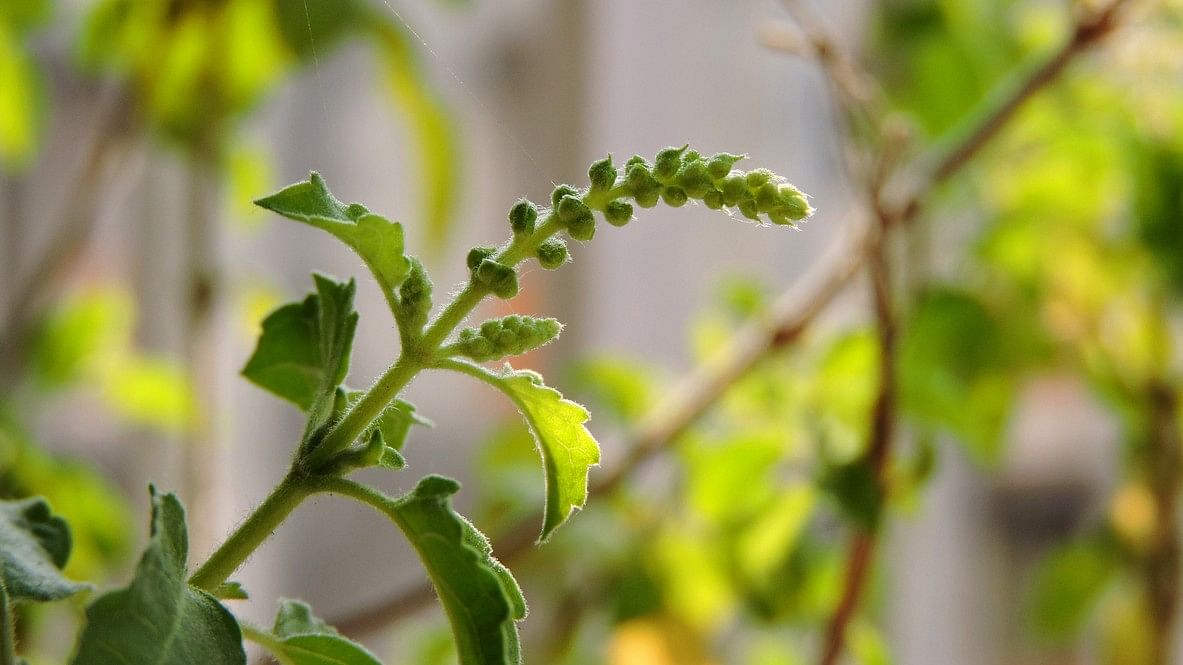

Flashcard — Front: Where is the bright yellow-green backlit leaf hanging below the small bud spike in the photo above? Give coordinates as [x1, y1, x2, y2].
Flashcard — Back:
[440, 361, 600, 542]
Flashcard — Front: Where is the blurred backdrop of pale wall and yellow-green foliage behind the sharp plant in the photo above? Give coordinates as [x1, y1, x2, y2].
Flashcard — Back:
[0, 0, 1183, 665]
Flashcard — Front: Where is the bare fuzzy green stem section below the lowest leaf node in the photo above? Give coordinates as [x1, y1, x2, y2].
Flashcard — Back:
[189, 474, 312, 592]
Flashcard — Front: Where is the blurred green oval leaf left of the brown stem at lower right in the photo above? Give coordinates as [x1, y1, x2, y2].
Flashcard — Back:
[1028, 540, 1118, 641]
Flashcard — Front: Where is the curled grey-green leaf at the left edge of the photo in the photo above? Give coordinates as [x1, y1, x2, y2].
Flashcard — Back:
[0, 498, 88, 601]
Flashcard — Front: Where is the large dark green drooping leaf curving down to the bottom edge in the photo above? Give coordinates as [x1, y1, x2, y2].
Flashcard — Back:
[323, 476, 526, 665]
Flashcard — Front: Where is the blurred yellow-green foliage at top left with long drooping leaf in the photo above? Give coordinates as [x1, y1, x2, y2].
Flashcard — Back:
[79, 0, 459, 250]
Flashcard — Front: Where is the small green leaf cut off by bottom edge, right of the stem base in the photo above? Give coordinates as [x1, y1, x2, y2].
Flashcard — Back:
[246, 599, 382, 665]
